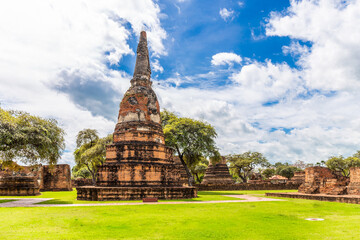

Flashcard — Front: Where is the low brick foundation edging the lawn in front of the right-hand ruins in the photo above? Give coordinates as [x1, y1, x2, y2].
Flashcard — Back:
[265, 192, 360, 204]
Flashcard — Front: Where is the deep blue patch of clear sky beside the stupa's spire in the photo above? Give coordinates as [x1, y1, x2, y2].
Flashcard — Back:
[118, 0, 295, 81]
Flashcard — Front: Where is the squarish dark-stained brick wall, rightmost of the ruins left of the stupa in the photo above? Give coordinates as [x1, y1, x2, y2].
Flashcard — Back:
[40, 164, 72, 191]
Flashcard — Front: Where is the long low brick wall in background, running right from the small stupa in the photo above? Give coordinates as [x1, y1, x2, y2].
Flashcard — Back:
[195, 182, 300, 191]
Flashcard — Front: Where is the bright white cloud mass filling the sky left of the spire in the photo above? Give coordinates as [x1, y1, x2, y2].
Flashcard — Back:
[0, 0, 166, 166]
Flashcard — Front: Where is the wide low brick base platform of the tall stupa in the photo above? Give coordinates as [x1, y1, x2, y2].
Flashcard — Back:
[76, 186, 197, 201]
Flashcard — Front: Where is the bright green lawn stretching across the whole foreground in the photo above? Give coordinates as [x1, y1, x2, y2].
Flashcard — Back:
[0, 191, 360, 239]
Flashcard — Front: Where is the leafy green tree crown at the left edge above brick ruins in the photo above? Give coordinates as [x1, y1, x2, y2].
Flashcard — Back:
[0, 108, 65, 165]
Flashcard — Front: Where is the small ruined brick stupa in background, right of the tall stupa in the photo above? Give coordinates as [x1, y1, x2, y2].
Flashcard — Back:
[201, 157, 234, 185]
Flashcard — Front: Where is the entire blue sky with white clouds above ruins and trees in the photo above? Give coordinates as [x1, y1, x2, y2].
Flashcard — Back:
[0, 0, 360, 165]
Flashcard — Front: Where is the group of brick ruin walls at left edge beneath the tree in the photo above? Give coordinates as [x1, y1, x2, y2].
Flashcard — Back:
[0, 164, 72, 196]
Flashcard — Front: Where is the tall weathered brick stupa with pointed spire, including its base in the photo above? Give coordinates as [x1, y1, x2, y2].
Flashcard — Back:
[77, 31, 197, 201]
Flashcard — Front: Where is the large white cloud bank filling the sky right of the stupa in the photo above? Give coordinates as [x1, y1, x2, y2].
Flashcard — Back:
[157, 0, 360, 163]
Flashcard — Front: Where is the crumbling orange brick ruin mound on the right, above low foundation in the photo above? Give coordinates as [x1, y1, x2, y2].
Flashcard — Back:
[299, 167, 349, 195]
